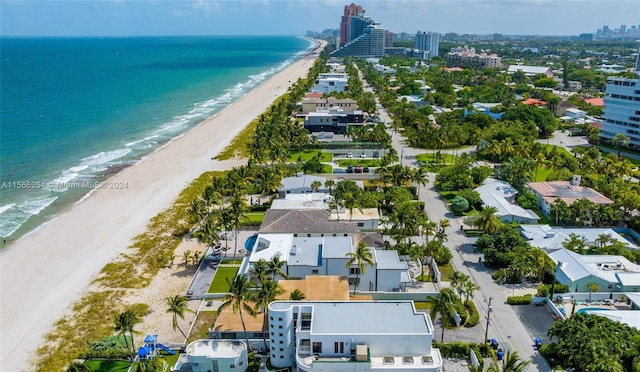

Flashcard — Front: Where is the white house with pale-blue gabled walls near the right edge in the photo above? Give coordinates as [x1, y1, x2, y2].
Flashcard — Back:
[547, 248, 640, 292]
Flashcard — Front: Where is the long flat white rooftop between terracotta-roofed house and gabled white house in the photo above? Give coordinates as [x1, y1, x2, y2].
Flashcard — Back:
[520, 225, 637, 249]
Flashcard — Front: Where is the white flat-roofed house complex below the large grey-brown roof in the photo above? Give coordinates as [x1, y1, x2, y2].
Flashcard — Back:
[239, 234, 411, 292]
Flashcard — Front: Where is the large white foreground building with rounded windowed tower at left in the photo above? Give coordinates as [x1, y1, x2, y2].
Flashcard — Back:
[269, 301, 442, 372]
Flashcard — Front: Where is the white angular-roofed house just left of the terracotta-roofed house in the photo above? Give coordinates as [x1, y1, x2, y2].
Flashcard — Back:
[475, 178, 540, 223]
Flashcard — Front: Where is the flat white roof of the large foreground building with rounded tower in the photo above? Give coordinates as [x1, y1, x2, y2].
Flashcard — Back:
[269, 301, 433, 336]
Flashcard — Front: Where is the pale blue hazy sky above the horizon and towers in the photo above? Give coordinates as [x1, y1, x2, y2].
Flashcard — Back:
[0, 0, 640, 36]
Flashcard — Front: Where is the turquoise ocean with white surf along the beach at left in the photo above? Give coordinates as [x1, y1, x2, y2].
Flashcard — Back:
[0, 36, 313, 246]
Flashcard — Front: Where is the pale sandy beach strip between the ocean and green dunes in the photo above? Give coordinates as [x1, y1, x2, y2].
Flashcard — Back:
[0, 41, 315, 371]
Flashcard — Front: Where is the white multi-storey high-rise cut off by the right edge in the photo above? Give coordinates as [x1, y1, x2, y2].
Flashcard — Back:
[600, 76, 640, 148]
